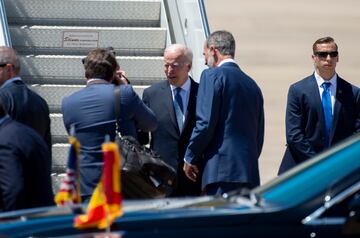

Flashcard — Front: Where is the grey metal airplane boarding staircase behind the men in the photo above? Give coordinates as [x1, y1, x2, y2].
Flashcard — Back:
[0, 0, 208, 191]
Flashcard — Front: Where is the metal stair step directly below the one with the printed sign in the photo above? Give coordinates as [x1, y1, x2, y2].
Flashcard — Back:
[20, 55, 164, 85]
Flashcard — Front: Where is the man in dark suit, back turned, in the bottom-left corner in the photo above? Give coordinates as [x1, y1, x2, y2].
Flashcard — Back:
[0, 100, 54, 211]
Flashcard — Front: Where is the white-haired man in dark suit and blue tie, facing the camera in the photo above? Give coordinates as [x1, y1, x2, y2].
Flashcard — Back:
[143, 44, 200, 196]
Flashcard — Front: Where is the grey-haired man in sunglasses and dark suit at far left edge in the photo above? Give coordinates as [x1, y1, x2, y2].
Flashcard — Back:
[0, 46, 51, 152]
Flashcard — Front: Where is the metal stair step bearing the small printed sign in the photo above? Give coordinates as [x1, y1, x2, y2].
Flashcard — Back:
[9, 25, 166, 56]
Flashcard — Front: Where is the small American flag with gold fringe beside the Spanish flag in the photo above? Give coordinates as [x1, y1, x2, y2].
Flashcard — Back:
[55, 136, 81, 205]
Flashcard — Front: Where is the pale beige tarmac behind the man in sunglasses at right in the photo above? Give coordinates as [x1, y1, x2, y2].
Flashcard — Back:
[205, 0, 360, 183]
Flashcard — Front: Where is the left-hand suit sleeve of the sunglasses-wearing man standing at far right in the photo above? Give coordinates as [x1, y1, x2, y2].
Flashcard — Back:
[286, 85, 316, 162]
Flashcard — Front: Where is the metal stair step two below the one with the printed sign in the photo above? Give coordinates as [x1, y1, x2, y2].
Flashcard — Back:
[29, 84, 148, 113]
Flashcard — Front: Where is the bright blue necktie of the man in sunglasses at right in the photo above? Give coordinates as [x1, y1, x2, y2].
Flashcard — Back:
[321, 82, 332, 147]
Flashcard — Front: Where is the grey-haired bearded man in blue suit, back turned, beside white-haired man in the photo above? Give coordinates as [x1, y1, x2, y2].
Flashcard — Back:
[184, 31, 264, 195]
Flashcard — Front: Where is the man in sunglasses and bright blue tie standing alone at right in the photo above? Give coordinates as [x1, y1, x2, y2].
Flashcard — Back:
[279, 37, 360, 174]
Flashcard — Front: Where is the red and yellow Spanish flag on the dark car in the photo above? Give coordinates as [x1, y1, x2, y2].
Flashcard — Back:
[74, 142, 123, 229]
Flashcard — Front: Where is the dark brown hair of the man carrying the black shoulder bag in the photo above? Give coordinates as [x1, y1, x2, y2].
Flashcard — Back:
[84, 48, 118, 81]
